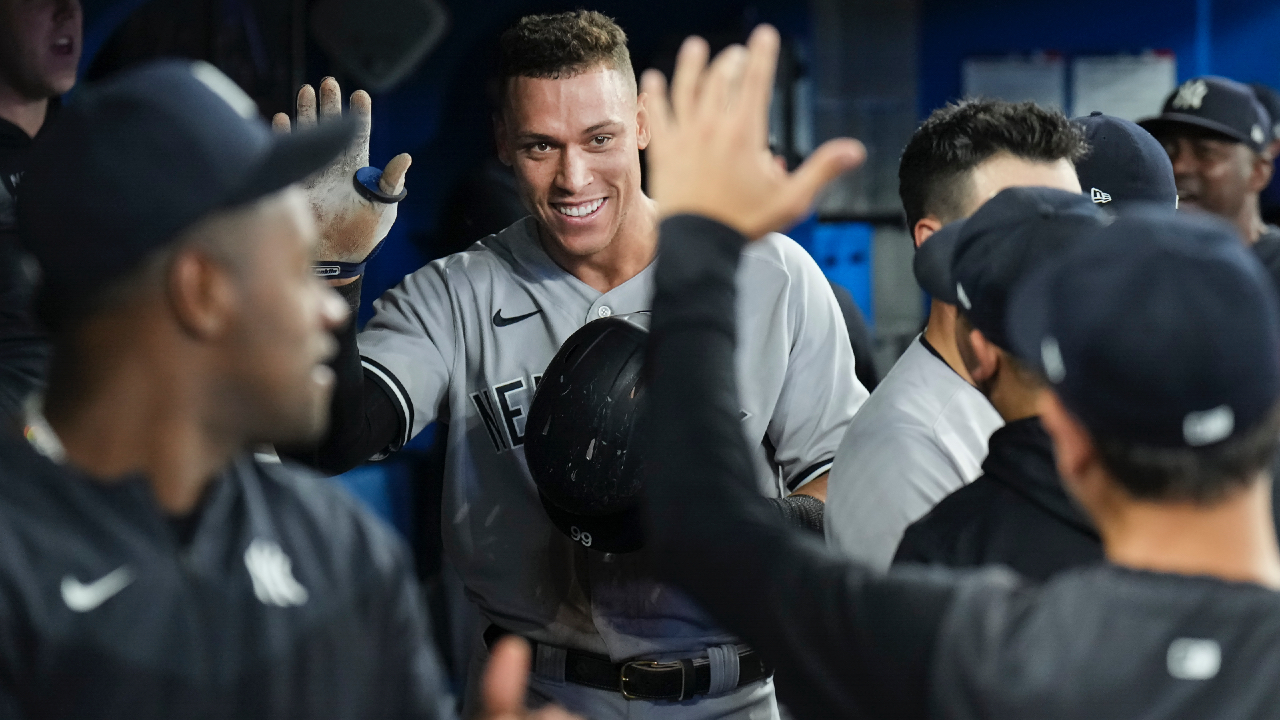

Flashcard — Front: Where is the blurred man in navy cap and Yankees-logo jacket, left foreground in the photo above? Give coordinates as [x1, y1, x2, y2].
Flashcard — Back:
[0, 61, 570, 720]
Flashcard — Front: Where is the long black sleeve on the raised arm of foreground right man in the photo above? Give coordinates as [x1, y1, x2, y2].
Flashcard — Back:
[645, 217, 950, 717]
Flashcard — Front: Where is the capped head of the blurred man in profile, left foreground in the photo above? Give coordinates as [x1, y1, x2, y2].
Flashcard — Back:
[18, 61, 353, 442]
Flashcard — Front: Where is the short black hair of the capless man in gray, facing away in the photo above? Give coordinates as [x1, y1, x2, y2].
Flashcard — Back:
[897, 100, 1088, 232]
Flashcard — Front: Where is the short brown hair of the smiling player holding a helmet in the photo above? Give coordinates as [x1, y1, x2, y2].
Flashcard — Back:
[498, 10, 635, 97]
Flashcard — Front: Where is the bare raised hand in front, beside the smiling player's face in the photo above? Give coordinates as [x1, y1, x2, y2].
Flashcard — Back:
[643, 26, 867, 240]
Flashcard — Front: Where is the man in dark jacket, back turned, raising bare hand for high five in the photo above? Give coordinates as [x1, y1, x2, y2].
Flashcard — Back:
[644, 29, 1280, 720]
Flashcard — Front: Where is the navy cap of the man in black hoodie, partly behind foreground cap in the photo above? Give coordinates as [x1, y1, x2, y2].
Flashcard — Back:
[916, 187, 1107, 350]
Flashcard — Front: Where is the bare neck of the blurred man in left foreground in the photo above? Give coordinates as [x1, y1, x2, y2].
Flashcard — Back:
[46, 327, 242, 515]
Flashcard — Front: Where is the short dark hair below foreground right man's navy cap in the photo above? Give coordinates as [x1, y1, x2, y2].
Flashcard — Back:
[1094, 406, 1280, 505]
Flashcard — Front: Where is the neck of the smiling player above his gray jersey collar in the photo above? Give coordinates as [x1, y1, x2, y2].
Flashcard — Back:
[543, 195, 658, 293]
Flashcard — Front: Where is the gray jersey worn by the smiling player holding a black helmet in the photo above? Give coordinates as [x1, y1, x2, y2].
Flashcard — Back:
[358, 218, 867, 660]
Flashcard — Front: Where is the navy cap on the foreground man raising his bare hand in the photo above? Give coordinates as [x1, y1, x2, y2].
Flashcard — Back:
[1009, 207, 1280, 447]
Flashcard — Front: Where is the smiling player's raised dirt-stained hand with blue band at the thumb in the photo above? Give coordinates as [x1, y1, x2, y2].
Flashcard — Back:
[271, 77, 413, 263]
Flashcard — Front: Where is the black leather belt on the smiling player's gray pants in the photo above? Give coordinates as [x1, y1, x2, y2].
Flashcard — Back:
[484, 625, 773, 701]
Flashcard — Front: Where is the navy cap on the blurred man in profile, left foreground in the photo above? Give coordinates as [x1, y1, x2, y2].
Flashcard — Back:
[18, 60, 356, 329]
